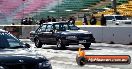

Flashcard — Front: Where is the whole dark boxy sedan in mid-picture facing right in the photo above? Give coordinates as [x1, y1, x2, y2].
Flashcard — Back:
[30, 22, 95, 49]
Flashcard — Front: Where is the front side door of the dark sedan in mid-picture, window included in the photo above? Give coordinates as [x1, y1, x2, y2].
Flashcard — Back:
[45, 24, 55, 44]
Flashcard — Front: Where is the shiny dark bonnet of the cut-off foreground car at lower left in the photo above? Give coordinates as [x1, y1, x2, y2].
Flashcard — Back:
[0, 49, 47, 64]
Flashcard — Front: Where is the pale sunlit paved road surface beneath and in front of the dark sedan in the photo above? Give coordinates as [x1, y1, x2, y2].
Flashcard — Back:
[21, 41, 132, 69]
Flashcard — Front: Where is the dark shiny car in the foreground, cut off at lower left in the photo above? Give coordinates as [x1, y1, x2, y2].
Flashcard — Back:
[0, 30, 52, 69]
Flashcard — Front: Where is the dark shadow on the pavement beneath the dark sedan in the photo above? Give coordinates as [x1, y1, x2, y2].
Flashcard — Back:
[42, 46, 101, 51]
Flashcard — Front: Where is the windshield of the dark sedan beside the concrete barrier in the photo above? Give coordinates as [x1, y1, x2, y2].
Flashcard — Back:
[53, 23, 79, 31]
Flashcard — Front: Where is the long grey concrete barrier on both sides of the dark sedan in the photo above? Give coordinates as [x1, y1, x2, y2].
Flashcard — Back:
[0, 25, 132, 44]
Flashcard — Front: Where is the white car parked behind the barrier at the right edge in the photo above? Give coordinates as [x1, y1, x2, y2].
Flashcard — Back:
[105, 15, 132, 25]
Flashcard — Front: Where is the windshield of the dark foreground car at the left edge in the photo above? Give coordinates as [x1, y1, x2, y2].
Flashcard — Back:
[0, 32, 23, 48]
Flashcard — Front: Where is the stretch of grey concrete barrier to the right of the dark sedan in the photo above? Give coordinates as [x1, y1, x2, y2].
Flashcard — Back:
[78, 26, 132, 44]
